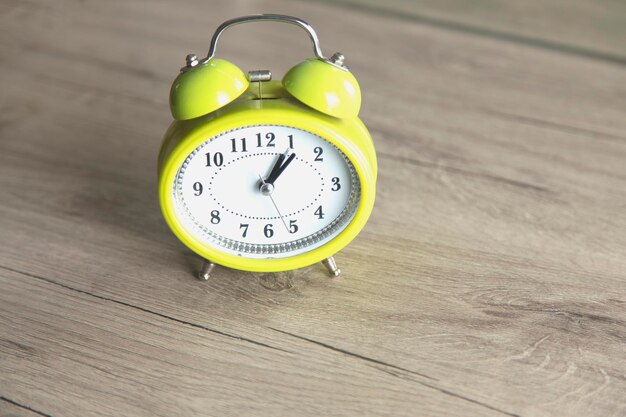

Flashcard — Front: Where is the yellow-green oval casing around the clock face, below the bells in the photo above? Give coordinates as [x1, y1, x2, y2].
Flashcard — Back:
[158, 81, 377, 272]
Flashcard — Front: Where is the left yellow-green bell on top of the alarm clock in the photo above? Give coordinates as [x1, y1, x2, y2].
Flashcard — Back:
[170, 55, 249, 120]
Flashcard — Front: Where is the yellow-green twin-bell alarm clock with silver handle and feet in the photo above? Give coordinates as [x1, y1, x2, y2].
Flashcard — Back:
[158, 15, 377, 279]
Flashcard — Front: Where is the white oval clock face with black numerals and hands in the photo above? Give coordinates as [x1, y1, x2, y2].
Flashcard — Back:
[172, 125, 361, 259]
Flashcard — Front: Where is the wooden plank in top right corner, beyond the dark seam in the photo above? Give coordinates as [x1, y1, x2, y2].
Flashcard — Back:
[322, 0, 626, 64]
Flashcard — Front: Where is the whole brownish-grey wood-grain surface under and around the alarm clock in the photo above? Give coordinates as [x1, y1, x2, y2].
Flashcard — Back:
[0, 0, 626, 417]
